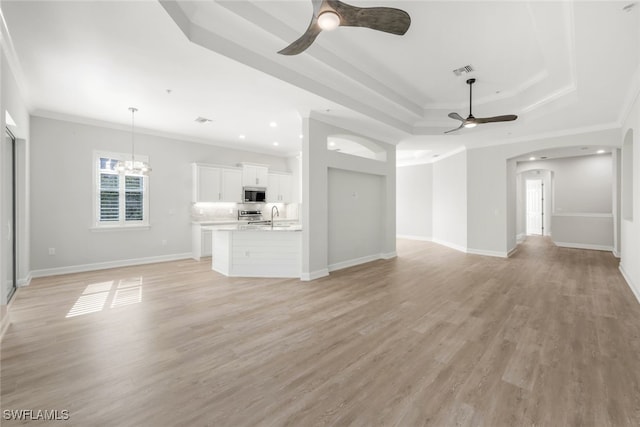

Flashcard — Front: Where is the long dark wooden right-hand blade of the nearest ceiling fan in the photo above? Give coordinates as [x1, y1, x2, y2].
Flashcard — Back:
[326, 0, 411, 36]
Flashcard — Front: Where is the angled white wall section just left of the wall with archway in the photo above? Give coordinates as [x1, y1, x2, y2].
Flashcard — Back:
[433, 151, 468, 251]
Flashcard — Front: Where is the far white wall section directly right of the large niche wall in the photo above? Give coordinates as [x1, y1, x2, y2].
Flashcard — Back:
[396, 164, 433, 240]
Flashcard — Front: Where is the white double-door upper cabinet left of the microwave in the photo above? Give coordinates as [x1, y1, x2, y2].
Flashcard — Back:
[192, 163, 242, 203]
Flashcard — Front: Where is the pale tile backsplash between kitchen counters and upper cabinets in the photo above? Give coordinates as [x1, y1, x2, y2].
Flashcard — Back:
[191, 203, 300, 222]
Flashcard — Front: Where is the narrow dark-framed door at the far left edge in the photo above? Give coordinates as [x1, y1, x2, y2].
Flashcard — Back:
[2, 129, 17, 301]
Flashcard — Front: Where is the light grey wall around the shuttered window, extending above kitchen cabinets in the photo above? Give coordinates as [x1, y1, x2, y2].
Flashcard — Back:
[31, 117, 287, 276]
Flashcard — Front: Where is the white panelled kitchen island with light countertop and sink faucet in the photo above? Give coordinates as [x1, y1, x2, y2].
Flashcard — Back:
[211, 225, 302, 278]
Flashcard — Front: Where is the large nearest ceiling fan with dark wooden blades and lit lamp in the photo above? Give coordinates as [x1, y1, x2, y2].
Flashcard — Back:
[278, 0, 411, 55]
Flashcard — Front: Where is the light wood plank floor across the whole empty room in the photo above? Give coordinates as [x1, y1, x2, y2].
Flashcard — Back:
[1, 238, 640, 427]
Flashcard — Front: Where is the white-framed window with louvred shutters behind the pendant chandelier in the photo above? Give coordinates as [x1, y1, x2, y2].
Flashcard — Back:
[94, 152, 149, 227]
